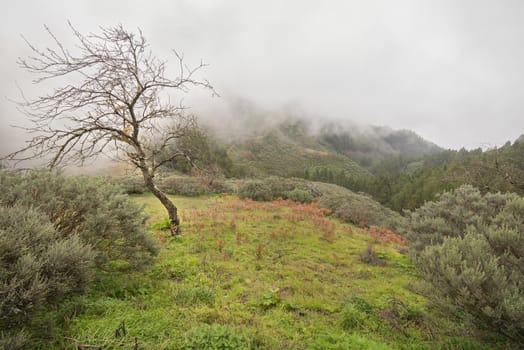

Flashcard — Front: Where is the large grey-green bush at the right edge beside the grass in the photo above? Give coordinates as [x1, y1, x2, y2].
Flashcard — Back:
[411, 186, 524, 346]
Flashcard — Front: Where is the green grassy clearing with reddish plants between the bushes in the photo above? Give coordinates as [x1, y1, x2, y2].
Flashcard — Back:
[43, 194, 508, 349]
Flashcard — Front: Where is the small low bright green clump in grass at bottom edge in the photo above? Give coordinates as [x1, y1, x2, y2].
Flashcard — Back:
[182, 324, 257, 350]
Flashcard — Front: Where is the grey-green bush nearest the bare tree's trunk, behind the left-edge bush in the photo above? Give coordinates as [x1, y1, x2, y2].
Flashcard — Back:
[0, 171, 158, 267]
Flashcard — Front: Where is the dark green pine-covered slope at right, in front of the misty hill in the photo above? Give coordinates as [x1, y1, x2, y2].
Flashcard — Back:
[367, 137, 524, 210]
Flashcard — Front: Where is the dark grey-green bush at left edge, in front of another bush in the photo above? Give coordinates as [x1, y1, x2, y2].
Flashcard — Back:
[0, 206, 95, 329]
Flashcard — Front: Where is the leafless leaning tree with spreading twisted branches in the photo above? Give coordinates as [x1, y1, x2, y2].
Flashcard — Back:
[6, 24, 215, 234]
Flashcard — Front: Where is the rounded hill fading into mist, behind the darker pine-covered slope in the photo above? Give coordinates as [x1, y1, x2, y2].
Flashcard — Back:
[219, 118, 441, 190]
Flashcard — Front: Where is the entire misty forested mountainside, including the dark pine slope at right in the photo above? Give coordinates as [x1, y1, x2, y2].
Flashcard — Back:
[181, 118, 524, 212]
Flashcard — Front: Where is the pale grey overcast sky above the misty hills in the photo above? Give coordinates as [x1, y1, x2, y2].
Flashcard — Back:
[0, 0, 524, 151]
